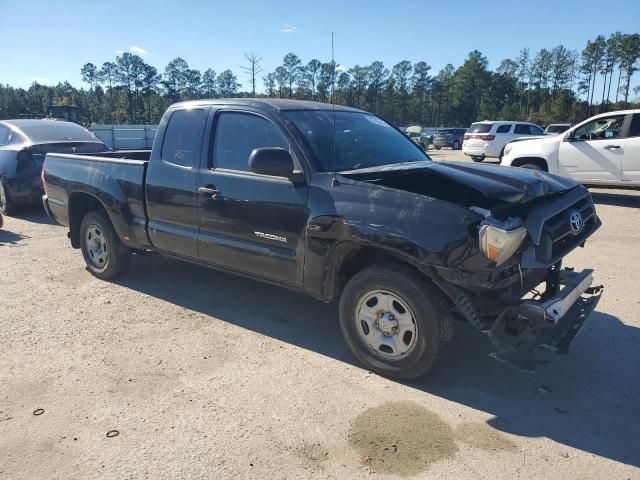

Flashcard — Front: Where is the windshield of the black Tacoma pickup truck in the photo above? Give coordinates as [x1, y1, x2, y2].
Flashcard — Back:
[283, 110, 430, 172]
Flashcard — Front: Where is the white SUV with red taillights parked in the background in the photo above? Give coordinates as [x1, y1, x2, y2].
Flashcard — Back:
[462, 121, 544, 162]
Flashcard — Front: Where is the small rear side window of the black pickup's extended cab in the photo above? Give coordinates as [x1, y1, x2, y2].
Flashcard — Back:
[162, 110, 204, 167]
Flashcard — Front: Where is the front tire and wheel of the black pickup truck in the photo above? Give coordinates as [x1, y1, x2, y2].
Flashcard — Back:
[340, 265, 453, 380]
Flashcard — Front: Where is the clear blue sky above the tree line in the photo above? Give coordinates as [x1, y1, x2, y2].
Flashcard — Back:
[0, 0, 640, 93]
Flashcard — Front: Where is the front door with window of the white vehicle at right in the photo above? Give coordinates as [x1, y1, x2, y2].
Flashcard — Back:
[558, 115, 626, 183]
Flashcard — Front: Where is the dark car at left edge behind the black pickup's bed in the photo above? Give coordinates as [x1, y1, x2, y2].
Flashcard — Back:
[0, 120, 109, 215]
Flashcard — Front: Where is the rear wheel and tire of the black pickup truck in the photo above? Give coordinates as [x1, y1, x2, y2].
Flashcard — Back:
[80, 210, 131, 280]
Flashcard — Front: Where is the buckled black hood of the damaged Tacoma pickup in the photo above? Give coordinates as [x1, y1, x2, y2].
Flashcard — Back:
[340, 161, 577, 208]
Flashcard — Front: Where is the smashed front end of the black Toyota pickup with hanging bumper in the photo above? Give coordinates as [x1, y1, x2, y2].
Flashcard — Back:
[438, 187, 603, 371]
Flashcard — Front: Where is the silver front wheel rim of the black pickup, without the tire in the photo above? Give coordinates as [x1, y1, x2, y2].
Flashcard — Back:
[355, 290, 418, 360]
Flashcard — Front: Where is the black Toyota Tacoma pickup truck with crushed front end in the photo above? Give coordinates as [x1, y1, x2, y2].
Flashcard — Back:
[42, 99, 602, 379]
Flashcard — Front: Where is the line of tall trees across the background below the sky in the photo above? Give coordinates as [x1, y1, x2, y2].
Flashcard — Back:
[0, 32, 640, 127]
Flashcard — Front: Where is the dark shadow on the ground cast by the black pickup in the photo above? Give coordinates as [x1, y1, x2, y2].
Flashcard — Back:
[117, 257, 640, 466]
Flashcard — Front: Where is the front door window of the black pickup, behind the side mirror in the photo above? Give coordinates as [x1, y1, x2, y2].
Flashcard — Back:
[213, 112, 289, 172]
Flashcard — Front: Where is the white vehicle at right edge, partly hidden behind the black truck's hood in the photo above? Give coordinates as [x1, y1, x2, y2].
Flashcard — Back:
[500, 110, 640, 186]
